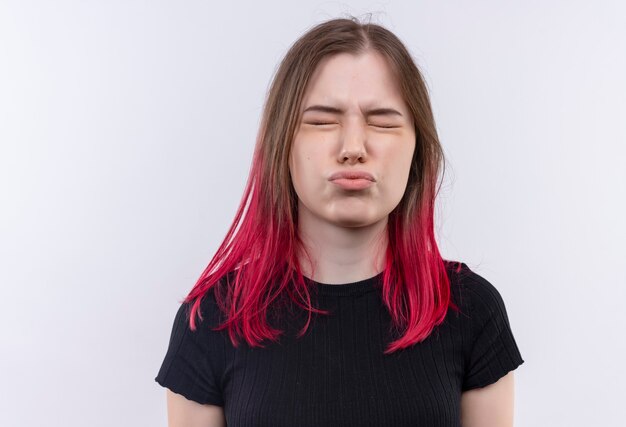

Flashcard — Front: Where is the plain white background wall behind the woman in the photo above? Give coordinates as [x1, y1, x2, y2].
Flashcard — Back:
[0, 0, 626, 427]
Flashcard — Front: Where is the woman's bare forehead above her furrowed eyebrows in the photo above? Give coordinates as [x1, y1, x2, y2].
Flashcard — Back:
[302, 51, 404, 109]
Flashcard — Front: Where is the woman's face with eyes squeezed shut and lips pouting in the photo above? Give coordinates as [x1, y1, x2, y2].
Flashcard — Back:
[289, 52, 415, 227]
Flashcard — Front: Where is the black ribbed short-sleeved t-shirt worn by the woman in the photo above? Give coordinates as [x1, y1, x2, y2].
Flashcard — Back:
[155, 264, 524, 427]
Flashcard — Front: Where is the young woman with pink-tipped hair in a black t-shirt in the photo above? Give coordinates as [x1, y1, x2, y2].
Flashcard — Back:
[155, 15, 523, 427]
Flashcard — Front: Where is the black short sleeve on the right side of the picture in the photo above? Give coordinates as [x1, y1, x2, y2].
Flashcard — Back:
[462, 272, 524, 391]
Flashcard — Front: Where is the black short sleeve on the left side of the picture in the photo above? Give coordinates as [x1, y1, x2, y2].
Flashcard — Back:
[154, 298, 224, 406]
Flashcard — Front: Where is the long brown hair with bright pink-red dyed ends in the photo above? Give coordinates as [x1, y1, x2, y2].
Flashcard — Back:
[184, 17, 460, 354]
